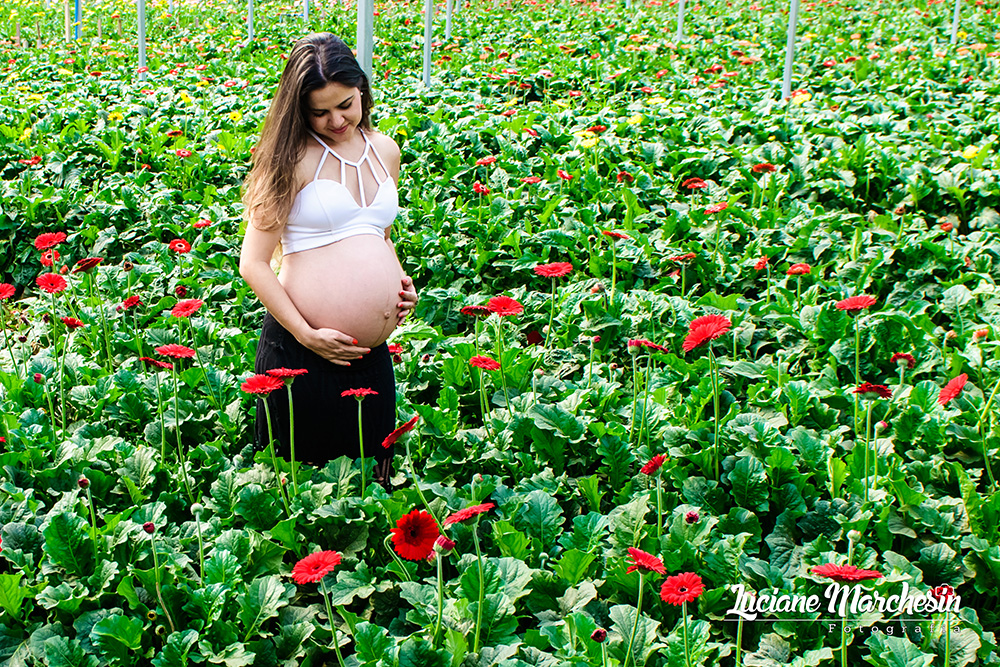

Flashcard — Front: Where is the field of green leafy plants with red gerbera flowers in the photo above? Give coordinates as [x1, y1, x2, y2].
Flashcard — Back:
[0, 0, 1000, 667]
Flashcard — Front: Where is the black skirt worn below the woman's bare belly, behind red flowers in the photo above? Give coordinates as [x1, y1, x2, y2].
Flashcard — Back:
[254, 313, 396, 484]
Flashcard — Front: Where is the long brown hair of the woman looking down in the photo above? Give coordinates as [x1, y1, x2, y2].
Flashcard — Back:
[243, 32, 372, 231]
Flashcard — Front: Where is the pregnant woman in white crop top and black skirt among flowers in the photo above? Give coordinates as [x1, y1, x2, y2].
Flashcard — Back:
[240, 33, 417, 485]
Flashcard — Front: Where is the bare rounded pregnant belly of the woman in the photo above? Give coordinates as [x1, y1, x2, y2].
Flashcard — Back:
[279, 234, 403, 347]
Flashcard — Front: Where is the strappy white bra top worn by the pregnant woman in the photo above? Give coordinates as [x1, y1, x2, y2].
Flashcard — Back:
[281, 132, 399, 255]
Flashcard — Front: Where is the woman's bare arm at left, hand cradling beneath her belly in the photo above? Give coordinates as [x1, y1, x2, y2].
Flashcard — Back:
[240, 220, 371, 366]
